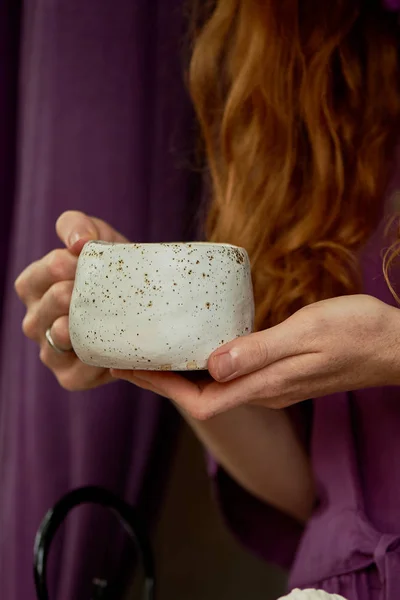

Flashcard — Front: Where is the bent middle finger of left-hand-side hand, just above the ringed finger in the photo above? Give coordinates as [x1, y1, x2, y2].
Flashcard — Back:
[22, 281, 74, 340]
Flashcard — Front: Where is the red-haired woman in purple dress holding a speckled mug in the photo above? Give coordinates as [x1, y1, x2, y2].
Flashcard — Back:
[16, 0, 400, 600]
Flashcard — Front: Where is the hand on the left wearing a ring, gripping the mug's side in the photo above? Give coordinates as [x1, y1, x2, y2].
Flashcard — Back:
[15, 211, 127, 391]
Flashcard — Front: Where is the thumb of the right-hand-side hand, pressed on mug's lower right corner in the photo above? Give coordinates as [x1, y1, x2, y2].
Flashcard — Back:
[208, 315, 305, 382]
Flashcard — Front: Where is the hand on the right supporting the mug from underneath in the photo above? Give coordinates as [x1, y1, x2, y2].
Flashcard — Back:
[112, 295, 400, 420]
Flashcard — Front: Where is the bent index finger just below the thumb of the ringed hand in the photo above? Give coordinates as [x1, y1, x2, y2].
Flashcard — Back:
[15, 248, 77, 306]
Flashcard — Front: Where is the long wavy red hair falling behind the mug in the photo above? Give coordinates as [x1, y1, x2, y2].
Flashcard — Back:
[189, 0, 400, 328]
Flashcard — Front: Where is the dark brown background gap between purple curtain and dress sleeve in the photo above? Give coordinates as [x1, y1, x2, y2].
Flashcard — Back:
[127, 427, 285, 600]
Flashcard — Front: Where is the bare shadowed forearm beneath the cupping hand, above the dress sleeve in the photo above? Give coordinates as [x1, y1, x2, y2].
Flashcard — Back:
[180, 406, 315, 522]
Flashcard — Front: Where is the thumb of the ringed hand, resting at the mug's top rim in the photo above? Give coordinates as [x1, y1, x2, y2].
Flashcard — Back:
[56, 210, 127, 254]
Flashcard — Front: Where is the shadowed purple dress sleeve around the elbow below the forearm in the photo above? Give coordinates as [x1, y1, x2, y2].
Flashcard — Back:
[208, 402, 312, 569]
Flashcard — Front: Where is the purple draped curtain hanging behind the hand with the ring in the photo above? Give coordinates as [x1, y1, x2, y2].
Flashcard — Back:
[0, 0, 198, 600]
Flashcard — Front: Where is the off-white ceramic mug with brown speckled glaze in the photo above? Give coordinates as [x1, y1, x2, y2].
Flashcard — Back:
[69, 242, 254, 371]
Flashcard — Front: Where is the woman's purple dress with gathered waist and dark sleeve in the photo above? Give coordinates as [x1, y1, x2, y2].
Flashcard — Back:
[210, 165, 400, 600]
